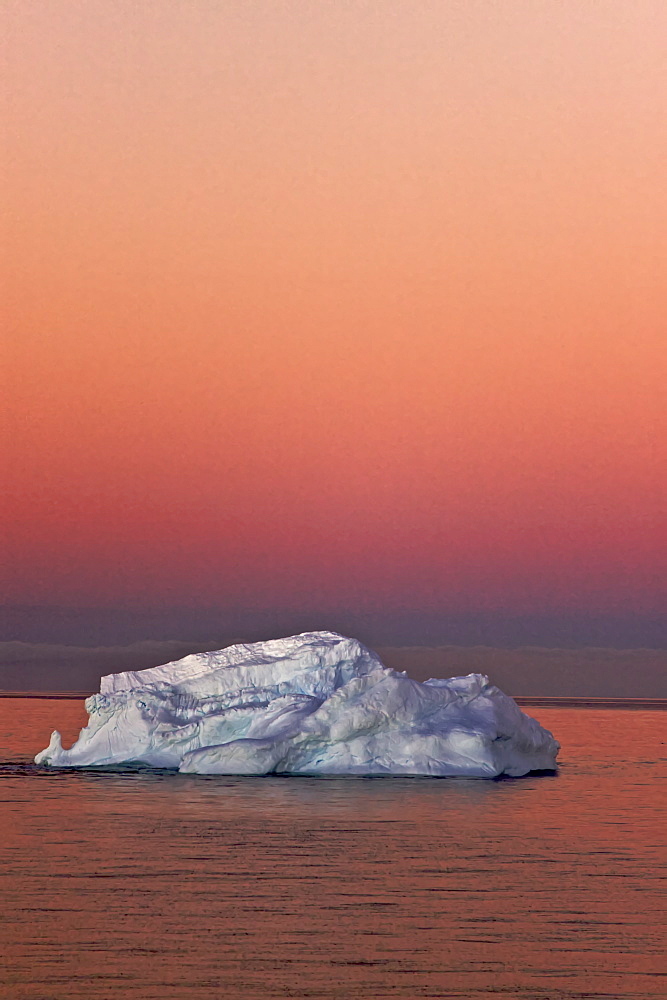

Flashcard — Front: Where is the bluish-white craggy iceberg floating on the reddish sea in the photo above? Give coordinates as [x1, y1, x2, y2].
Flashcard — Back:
[35, 632, 559, 778]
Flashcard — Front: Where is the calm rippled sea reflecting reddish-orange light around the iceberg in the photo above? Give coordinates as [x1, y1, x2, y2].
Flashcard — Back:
[0, 699, 667, 1000]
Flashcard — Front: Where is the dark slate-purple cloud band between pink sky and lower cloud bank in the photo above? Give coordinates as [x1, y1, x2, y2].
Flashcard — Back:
[0, 605, 667, 649]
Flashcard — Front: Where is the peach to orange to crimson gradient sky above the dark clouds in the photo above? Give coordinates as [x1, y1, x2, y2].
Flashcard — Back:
[2, 0, 667, 627]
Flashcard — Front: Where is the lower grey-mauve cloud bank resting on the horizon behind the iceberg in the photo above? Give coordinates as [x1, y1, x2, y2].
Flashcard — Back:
[0, 639, 667, 698]
